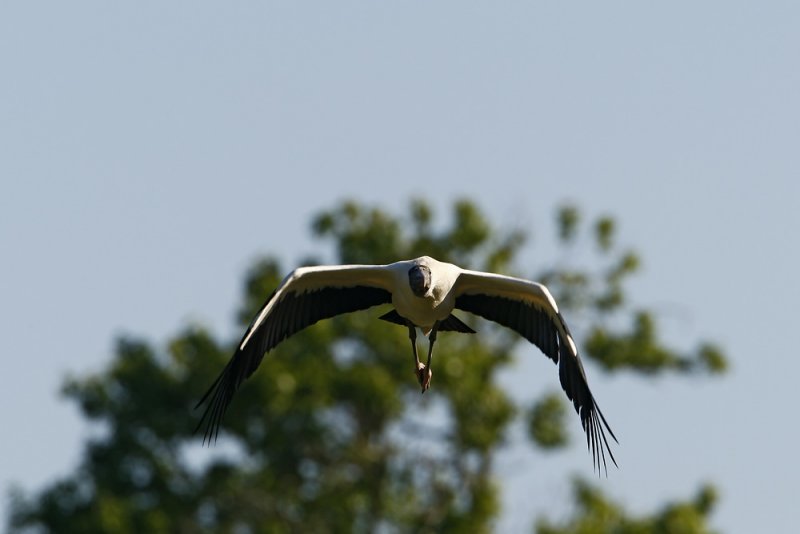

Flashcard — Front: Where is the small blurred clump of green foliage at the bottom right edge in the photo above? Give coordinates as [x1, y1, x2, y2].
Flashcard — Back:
[536, 480, 717, 534]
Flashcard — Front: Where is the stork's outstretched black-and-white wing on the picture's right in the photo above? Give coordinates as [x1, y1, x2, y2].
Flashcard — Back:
[453, 270, 617, 476]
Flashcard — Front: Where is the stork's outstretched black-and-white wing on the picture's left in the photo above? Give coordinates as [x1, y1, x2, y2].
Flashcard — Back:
[196, 265, 393, 442]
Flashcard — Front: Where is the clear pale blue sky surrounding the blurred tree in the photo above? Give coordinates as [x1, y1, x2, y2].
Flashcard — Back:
[0, 0, 800, 533]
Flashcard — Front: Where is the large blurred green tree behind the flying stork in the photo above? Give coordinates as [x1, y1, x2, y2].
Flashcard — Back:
[10, 200, 726, 533]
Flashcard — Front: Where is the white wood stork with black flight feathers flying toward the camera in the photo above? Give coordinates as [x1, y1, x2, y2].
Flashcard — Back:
[196, 256, 617, 468]
